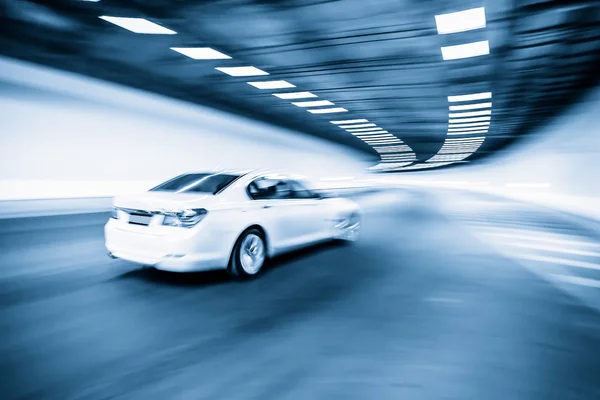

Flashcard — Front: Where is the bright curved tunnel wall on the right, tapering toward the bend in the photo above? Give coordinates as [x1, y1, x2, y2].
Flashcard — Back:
[399, 84, 600, 220]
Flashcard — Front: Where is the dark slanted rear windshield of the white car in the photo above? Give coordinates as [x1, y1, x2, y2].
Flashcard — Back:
[150, 174, 240, 194]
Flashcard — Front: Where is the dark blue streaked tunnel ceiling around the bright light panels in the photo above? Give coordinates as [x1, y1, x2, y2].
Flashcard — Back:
[0, 0, 600, 170]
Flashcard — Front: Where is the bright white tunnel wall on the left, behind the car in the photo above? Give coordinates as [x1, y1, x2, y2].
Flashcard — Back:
[0, 58, 365, 200]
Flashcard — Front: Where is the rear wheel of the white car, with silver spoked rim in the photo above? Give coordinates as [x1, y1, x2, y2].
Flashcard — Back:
[227, 228, 267, 279]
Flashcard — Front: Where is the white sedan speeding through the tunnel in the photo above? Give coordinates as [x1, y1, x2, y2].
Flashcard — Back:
[105, 171, 360, 278]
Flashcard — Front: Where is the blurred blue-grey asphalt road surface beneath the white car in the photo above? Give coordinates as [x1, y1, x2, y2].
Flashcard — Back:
[0, 191, 600, 400]
